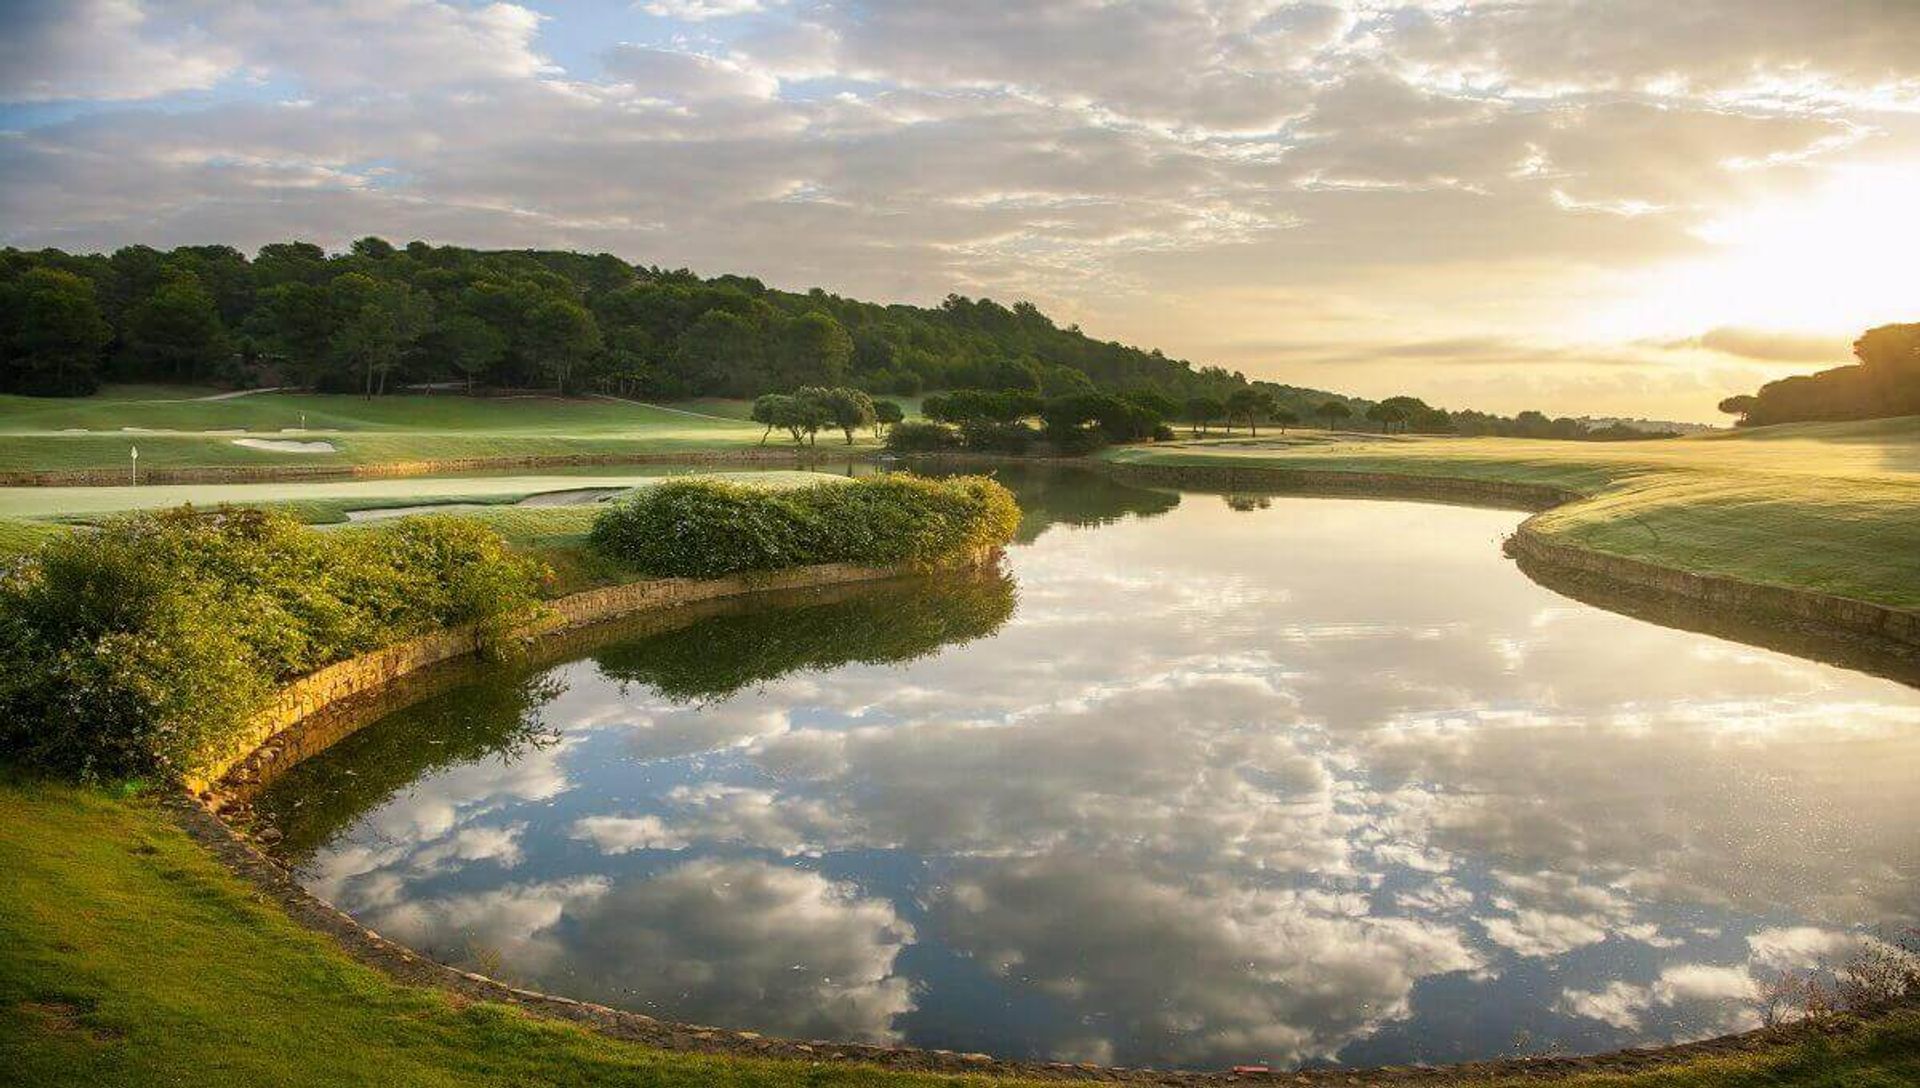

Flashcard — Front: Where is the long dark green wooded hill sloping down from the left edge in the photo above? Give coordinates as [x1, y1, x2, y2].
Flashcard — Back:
[0, 238, 1361, 405]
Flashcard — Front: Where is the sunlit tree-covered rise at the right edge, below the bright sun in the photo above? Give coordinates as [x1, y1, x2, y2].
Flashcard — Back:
[1720, 324, 1920, 426]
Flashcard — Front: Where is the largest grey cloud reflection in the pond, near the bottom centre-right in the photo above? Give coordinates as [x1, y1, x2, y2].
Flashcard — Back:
[937, 856, 1480, 1063]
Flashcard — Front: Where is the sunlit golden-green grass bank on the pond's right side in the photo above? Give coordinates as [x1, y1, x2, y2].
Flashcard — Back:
[1108, 416, 1920, 608]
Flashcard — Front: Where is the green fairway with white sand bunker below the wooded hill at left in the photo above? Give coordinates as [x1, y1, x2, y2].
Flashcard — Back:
[0, 390, 794, 472]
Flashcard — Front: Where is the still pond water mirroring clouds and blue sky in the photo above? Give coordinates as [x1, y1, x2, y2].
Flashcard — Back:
[261, 474, 1920, 1067]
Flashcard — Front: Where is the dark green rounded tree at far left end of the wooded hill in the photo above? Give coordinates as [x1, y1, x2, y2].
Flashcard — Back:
[0, 269, 113, 397]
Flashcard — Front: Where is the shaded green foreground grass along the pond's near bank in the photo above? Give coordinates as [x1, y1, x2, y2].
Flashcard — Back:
[0, 775, 1920, 1088]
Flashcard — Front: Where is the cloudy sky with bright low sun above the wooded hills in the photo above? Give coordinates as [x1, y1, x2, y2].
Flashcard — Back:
[0, 0, 1920, 420]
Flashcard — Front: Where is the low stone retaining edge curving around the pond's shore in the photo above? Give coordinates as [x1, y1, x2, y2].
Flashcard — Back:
[167, 472, 1912, 1086]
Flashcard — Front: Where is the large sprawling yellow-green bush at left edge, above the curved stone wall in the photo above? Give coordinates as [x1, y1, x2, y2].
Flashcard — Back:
[0, 507, 540, 777]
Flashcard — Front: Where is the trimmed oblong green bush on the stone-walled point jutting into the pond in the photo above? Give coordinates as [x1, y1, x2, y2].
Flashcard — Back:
[589, 474, 1020, 578]
